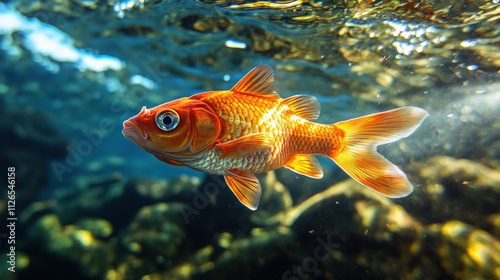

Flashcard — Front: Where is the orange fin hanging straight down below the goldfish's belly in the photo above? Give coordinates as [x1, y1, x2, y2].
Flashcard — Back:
[224, 169, 262, 210]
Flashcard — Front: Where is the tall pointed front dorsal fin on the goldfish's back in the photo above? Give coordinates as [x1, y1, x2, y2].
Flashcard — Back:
[231, 64, 279, 98]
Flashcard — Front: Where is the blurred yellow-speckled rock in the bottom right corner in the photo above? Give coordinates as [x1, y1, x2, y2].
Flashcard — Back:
[405, 221, 500, 279]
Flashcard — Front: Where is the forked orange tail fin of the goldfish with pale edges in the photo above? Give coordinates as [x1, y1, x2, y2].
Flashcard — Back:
[330, 107, 428, 197]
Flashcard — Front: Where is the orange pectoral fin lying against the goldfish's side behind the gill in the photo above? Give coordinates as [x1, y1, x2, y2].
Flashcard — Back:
[215, 133, 273, 157]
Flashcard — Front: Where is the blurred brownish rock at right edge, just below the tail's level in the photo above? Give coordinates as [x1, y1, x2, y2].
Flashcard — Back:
[402, 156, 500, 229]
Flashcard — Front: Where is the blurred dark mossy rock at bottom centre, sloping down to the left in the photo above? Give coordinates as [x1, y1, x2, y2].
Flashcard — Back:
[154, 228, 294, 280]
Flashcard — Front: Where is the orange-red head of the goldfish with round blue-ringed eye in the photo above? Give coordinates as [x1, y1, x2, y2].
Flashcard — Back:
[122, 98, 223, 163]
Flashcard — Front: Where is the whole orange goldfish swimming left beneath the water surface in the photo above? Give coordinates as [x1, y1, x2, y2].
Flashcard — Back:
[122, 65, 428, 210]
